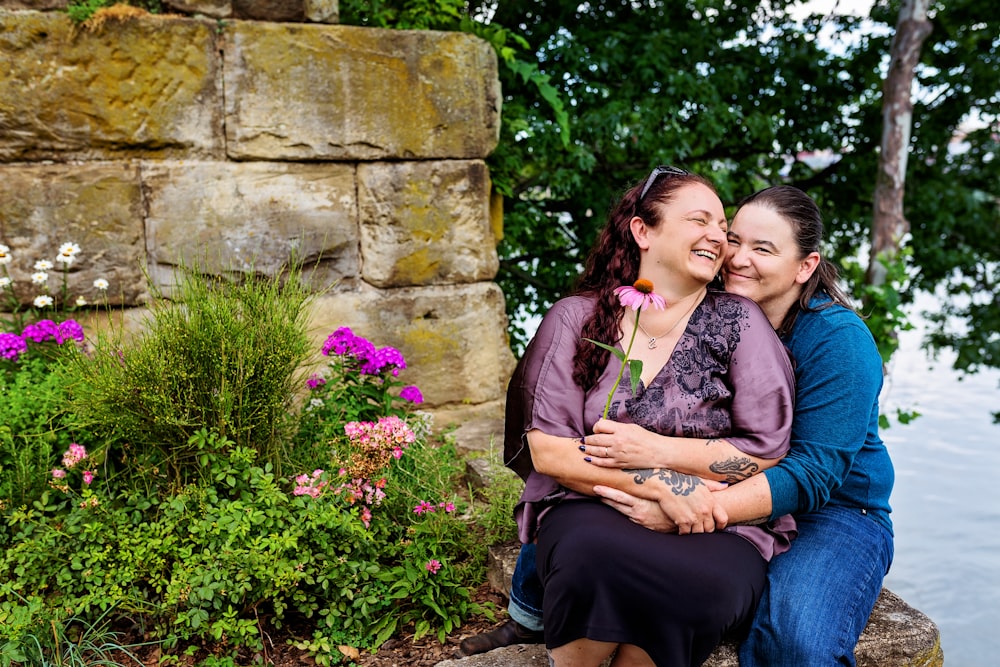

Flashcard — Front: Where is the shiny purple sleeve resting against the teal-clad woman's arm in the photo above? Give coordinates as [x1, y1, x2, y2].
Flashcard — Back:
[726, 297, 795, 459]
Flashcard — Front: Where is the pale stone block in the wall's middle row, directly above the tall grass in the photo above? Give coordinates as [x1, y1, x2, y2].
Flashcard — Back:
[142, 161, 361, 289]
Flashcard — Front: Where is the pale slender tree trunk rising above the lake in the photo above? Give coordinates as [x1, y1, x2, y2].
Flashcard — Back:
[865, 0, 931, 286]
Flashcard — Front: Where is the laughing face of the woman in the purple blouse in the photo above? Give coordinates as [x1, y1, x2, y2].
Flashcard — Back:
[632, 183, 727, 291]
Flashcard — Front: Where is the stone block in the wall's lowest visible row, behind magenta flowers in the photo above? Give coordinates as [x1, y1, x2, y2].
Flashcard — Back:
[310, 283, 514, 408]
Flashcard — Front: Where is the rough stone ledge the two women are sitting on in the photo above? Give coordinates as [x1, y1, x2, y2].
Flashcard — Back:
[436, 544, 944, 667]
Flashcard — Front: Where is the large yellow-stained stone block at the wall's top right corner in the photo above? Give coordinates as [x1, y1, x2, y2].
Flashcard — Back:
[224, 21, 500, 160]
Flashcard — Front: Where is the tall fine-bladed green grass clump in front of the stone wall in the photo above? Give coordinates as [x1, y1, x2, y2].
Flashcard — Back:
[73, 267, 309, 485]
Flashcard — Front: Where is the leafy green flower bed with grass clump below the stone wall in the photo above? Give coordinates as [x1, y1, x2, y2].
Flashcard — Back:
[0, 249, 509, 667]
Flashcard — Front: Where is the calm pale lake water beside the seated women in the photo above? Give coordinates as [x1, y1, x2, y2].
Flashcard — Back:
[882, 318, 1000, 667]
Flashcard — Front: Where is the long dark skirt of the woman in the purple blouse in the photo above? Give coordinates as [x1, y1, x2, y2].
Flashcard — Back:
[537, 500, 767, 667]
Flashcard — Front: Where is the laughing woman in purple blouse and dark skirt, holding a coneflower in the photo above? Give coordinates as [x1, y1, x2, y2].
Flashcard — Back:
[505, 167, 794, 667]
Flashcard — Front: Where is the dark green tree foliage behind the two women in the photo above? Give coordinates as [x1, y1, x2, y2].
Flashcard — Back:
[341, 0, 1000, 386]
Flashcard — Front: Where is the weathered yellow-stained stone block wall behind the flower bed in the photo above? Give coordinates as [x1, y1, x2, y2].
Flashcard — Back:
[0, 0, 514, 422]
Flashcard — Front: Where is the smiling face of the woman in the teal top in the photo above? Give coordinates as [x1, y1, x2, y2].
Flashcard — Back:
[722, 203, 819, 328]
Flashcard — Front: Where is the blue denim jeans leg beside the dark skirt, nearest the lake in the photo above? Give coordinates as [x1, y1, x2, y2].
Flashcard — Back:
[740, 506, 893, 667]
